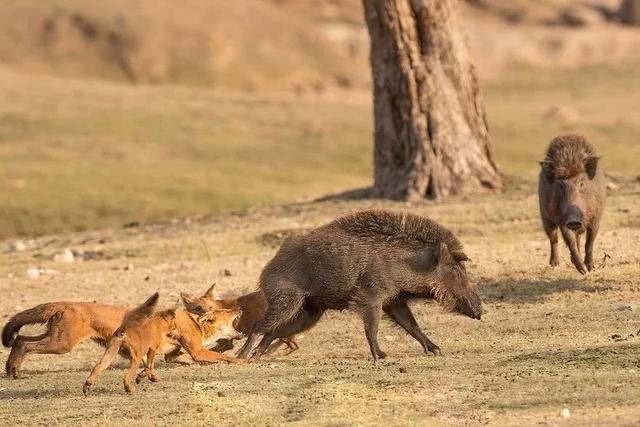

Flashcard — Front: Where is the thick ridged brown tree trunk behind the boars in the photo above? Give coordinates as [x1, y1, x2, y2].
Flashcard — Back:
[363, 0, 502, 200]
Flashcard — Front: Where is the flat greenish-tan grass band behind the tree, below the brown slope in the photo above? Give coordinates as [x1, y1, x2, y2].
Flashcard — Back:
[0, 63, 640, 238]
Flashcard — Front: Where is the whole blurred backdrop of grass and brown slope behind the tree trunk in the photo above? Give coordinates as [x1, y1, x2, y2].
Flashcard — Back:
[0, 0, 640, 238]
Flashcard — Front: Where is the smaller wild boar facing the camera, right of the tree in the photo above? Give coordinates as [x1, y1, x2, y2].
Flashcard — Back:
[538, 134, 607, 274]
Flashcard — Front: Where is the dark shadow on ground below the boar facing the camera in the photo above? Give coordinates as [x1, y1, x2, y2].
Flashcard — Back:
[478, 278, 605, 304]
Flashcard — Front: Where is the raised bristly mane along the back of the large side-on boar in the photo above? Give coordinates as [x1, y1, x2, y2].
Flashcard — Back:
[323, 210, 463, 252]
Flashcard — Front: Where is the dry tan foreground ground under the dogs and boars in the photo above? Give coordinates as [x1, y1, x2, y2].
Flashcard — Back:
[0, 180, 640, 425]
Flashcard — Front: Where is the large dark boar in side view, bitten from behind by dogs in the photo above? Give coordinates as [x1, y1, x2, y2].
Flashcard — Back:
[240, 211, 482, 361]
